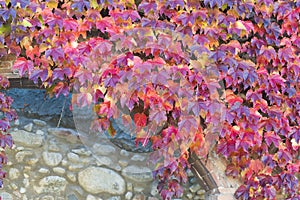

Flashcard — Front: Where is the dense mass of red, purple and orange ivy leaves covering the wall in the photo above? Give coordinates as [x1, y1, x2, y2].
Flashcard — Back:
[0, 0, 300, 199]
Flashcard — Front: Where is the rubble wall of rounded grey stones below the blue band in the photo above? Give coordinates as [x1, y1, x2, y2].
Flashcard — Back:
[0, 117, 205, 200]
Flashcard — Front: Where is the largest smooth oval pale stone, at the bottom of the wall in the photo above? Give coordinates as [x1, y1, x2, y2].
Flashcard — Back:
[78, 167, 125, 195]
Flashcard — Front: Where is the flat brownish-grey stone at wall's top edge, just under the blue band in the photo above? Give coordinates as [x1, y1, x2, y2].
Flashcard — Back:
[48, 128, 80, 143]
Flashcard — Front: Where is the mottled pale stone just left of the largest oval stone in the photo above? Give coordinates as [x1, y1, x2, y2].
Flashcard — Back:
[34, 176, 67, 194]
